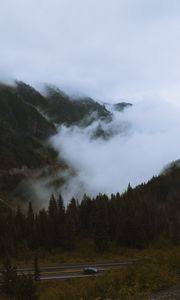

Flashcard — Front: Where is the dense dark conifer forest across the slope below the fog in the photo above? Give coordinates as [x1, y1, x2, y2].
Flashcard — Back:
[0, 165, 180, 256]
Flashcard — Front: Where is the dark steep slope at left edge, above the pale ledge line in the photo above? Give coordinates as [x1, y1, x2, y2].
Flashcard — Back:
[0, 85, 56, 170]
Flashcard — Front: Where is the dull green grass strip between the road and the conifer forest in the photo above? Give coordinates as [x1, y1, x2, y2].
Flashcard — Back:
[0, 239, 139, 267]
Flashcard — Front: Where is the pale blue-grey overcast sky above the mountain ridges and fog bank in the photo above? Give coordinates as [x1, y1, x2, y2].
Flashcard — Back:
[0, 0, 180, 103]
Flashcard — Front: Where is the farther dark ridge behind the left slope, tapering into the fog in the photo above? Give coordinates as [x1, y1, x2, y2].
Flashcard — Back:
[16, 82, 111, 126]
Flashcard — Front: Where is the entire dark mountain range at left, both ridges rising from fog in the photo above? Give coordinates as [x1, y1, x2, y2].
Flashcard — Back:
[0, 82, 132, 204]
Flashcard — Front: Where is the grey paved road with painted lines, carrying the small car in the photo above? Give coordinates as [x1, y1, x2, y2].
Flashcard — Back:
[0, 260, 136, 281]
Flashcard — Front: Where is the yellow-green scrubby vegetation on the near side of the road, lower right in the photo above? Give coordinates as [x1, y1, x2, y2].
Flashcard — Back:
[39, 248, 180, 300]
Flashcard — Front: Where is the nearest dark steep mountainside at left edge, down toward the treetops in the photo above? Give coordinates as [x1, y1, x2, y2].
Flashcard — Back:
[0, 84, 59, 200]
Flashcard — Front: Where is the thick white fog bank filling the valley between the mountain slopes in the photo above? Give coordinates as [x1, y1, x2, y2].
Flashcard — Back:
[51, 99, 180, 201]
